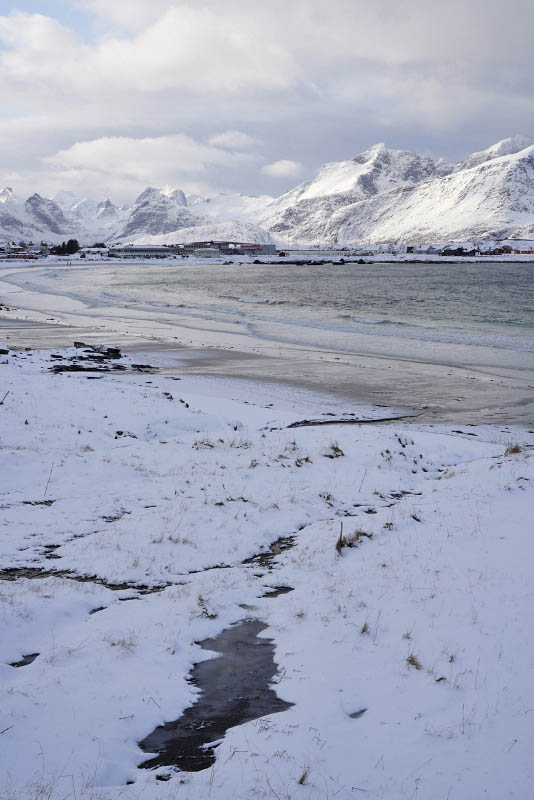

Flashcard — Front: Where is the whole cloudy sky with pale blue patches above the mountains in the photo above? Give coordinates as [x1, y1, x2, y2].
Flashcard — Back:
[0, 0, 534, 202]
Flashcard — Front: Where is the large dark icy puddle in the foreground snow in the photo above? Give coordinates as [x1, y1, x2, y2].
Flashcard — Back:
[139, 620, 293, 772]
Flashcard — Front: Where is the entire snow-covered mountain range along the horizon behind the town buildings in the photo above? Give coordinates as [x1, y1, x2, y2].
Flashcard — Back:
[0, 136, 534, 246]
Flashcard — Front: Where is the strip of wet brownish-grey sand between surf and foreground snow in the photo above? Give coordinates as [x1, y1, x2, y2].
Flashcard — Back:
[0, 310, 534, 428]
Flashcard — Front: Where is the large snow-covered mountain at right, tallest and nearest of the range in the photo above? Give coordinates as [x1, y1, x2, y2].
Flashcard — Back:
[258, 137, 534, 245]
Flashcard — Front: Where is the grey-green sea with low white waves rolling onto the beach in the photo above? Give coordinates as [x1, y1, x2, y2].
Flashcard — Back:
[4, 261, 534, 368]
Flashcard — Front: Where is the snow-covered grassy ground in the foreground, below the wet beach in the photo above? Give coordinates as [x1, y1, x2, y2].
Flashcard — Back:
[0, 350, 534, 800]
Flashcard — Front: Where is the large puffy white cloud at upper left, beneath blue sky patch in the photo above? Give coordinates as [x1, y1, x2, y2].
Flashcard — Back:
[0, 6, 299, 102]
